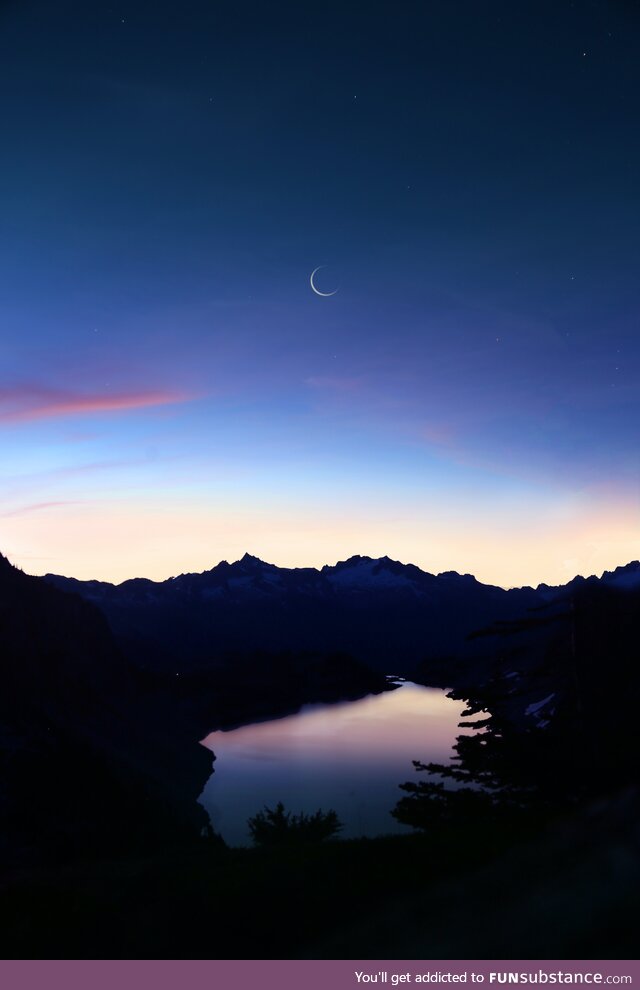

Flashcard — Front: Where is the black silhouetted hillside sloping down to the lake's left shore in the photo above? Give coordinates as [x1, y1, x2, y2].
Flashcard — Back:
[0, 557, 210, 865]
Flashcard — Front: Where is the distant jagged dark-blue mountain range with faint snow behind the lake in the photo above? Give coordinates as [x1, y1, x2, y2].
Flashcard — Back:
[45, 554, 640, 676]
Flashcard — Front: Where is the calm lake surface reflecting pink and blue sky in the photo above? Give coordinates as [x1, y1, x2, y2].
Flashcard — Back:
[200, 683, 464, 845]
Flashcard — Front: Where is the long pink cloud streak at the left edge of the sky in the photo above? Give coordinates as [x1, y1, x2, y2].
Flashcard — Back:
[0, 385, 193, 423]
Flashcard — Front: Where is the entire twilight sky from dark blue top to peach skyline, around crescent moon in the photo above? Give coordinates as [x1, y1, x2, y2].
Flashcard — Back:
[0, 0, 640, 586]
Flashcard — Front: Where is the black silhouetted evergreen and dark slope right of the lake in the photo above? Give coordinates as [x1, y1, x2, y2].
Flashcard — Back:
[392, 582, 640, 829]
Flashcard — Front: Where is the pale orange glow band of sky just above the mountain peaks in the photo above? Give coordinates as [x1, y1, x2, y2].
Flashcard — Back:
[0, 500, 640, 587]
